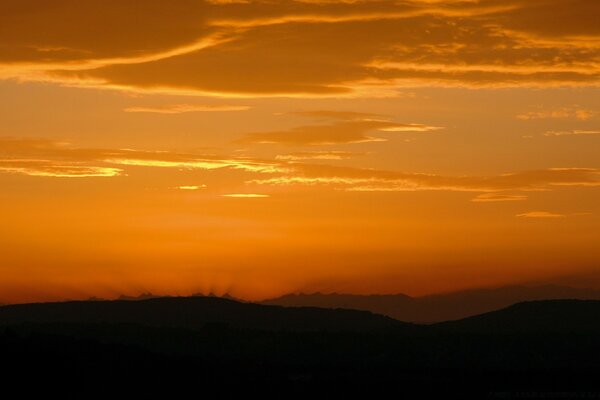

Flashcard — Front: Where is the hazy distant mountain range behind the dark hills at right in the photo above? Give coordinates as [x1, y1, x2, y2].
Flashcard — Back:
[260, 285, 600, 323]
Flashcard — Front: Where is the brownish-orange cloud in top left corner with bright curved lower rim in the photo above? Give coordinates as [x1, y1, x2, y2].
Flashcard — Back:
[0, 0, 216, 66]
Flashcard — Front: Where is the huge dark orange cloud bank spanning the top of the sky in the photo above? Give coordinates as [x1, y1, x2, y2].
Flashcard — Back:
[0, 0, 600, 95]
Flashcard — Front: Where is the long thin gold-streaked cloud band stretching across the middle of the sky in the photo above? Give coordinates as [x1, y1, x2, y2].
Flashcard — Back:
[0, 138, 600, 201]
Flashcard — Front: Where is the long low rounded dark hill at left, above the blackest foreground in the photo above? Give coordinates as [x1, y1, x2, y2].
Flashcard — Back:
[0, 296, 410, 331]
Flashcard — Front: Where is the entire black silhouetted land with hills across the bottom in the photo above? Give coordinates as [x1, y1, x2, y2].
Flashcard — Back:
[0, 297, 600, 399]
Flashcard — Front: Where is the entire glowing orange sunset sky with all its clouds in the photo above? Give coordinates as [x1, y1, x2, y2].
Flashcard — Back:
[0, 0, 600, 303]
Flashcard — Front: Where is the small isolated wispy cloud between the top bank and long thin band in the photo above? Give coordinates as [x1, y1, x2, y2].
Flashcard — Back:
[237, 111, 442, 146]
